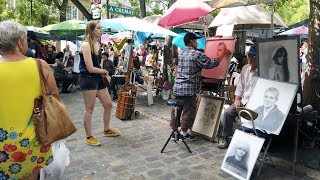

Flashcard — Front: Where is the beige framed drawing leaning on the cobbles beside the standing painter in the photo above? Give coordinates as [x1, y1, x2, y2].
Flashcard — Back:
[192, 95, 224, 141]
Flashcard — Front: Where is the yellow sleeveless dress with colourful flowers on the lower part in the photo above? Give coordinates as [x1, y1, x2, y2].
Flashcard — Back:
[0, 58, 53, 179]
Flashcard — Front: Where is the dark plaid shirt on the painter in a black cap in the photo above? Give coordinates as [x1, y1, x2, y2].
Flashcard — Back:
[173, 47, 220, 96]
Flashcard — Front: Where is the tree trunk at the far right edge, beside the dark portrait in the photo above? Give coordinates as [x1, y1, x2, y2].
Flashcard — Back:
[303, 0, 320, 111]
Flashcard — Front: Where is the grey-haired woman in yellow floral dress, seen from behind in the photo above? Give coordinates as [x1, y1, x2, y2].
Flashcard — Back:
[0, 21, 58, 179]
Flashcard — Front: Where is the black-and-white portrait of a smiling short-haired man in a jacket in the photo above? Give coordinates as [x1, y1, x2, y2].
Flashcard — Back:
[241, 78, 297, 135]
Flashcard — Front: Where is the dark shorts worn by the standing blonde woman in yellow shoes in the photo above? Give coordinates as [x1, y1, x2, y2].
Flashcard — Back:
[80, 74, 106, 91]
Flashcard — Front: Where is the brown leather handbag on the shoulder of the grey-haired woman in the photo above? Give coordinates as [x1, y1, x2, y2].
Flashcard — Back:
[33, 59, 77, 145]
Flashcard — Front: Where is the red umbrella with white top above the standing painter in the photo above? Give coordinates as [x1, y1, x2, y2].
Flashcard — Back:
[158, 0, 215, 27]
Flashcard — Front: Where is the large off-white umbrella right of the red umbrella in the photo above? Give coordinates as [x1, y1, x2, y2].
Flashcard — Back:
[209, 4, 287, 28]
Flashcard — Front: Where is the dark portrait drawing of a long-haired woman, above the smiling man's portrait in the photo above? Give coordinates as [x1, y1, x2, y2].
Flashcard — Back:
[257, 36, 300, 85]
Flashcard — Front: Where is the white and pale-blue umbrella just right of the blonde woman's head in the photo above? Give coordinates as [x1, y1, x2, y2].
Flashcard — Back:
[100, 17, 179, 36]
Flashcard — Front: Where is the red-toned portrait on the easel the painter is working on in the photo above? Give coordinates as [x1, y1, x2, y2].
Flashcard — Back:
[201, 36, 236, 80]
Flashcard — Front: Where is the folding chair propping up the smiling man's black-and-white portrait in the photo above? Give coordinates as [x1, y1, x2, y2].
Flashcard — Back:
[237, 107, 275, 176]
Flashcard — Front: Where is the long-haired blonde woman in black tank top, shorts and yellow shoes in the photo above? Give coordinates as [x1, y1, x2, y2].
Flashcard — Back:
[79, 21, 120, 146]
